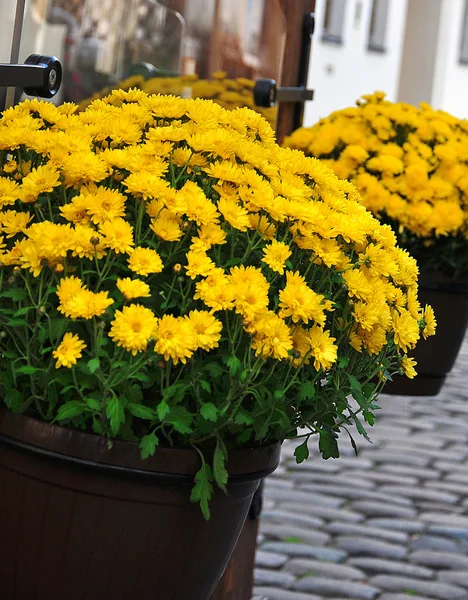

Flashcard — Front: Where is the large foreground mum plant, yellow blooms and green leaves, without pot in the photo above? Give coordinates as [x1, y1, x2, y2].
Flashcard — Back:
[0, 90, 434, 514]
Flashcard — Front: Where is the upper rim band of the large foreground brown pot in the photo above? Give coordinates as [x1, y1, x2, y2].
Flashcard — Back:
[0, 407, 281, 483]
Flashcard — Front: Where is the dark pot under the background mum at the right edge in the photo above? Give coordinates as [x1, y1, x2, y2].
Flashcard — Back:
[383, 276, 468, 396]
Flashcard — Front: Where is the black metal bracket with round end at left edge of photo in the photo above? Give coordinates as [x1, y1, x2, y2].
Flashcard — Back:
[0, 54, 62, 98]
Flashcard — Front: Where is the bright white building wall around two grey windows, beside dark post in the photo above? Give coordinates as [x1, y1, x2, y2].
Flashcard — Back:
[304, 0, 408, 125]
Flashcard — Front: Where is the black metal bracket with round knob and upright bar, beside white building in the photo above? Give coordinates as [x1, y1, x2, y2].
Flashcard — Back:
[253, 13, 315, 128]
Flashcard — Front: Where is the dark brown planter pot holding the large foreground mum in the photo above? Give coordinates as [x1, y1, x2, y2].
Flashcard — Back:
[0, 410, 280, 600]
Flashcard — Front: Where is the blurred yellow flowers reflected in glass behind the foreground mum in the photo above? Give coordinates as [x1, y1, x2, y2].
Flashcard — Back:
[79, 71, 277, 126]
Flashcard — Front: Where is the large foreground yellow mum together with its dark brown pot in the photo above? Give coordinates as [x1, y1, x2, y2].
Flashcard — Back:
[0, 90, 430, 600]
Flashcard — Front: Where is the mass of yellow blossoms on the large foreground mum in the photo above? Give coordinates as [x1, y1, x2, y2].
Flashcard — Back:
[0, 89, 432, 372]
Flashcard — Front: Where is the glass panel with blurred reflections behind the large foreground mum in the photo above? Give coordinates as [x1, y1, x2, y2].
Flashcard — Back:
[11, 0, 287, 124]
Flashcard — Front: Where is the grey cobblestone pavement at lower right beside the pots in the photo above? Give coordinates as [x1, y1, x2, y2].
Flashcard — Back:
[254, 337, 468, 600]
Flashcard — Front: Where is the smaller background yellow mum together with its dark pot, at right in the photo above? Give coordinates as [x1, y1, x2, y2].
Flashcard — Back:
[285, 92, 468, 395]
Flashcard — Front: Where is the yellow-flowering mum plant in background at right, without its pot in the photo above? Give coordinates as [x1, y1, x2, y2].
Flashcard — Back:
[285, 92, 468, 277]
